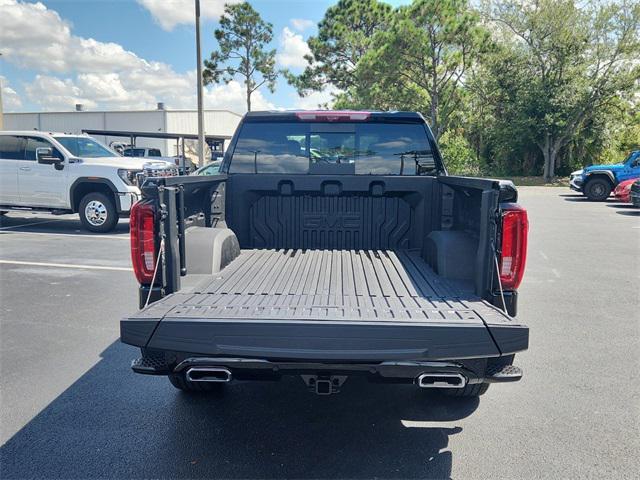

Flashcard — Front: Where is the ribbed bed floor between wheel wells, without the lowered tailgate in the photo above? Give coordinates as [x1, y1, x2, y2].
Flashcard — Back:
[197, 250, 470, 298]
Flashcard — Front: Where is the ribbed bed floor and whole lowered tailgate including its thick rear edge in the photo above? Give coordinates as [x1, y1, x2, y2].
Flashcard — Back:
[122, 249, 528, 361]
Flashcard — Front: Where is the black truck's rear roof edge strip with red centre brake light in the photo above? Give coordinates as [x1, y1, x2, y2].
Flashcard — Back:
[244, 110, 424, 123]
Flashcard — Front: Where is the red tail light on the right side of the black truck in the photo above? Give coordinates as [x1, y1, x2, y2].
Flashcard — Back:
[500, 203, 529, 290]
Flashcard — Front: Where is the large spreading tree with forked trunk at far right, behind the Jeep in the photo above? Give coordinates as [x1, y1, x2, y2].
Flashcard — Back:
[488, 0, 640, 181]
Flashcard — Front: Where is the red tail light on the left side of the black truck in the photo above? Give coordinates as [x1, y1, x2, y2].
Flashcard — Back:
[129, 201, 157, 285]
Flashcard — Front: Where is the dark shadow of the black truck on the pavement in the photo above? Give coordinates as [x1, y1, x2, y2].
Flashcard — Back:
[0, 342, 479, 479]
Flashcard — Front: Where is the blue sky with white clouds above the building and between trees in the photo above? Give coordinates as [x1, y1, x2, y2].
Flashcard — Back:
[0, 0, 408, 111]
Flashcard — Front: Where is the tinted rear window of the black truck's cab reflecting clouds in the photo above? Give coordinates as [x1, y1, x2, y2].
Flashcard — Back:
[229, 122, 435, 175]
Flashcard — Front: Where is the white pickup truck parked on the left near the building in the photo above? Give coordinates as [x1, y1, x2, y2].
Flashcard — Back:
[0, 131, 178, 232]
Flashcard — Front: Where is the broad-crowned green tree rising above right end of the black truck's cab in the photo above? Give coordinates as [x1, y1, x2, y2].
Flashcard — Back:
[355, 0, 490, 138]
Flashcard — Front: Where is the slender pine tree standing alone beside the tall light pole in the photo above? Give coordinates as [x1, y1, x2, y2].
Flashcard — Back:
[203, 2, 278, 111]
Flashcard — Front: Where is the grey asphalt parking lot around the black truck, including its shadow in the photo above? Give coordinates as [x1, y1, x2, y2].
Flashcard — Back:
[0, 187, 640, 479]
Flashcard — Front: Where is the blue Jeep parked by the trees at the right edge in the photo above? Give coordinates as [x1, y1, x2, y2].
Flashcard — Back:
[569, 150, 640, 202]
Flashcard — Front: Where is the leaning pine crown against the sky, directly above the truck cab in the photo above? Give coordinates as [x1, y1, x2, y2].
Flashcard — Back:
[285, 0, 392, 102]
